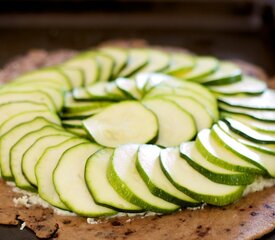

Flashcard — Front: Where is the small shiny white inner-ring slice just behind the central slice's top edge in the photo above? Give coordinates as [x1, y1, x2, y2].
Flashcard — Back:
[115, 78, 142, 100]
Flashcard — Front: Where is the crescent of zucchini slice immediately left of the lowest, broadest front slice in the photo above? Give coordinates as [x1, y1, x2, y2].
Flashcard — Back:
[35, 138, 87, 210]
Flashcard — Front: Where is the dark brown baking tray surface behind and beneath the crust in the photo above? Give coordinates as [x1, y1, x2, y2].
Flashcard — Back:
[0, 0, 275, 240]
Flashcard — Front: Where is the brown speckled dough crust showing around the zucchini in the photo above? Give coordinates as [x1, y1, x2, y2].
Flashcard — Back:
[0, 41, 275, 240]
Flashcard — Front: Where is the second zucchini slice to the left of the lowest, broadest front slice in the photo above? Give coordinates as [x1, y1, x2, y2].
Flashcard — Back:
[21, 134, 72, 186]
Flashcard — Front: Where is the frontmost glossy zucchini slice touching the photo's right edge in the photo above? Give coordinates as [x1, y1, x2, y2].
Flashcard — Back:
[212, 122, 275, 176]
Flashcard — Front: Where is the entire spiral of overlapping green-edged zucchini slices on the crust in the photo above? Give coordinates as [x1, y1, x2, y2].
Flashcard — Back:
[0, 47, 275, 217]
